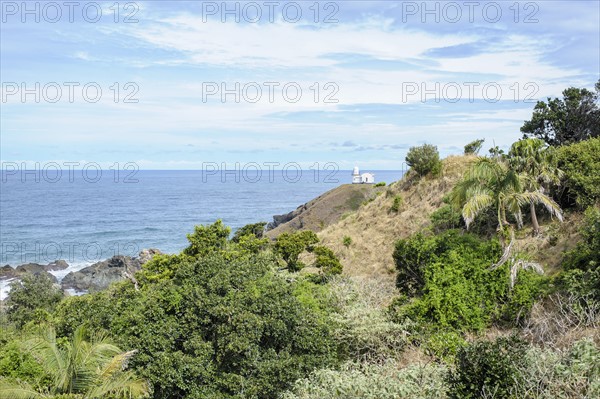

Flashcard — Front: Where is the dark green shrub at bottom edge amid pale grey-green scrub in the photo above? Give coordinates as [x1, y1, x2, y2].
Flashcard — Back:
[447, 336, 527, 399]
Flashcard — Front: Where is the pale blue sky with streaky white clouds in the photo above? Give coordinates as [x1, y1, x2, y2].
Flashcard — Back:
[0, 0, 600, 170]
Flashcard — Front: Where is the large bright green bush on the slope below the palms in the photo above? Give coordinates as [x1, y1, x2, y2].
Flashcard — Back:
[390, 230, 534, 331]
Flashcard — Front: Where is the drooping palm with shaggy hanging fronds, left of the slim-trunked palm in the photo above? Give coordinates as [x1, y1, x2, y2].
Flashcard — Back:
[452, 157, 562, 232]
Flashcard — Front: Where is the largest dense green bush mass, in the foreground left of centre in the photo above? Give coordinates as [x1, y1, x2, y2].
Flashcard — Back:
[57, 253, 337, 399]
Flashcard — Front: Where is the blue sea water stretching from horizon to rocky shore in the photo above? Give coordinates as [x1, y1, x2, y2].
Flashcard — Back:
[0, 170, 402, 268]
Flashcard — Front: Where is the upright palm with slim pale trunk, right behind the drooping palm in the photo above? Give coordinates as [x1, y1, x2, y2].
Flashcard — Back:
[508, 139, 563, 235]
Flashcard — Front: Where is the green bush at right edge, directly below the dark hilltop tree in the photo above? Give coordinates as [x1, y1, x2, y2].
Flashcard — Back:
[556, 137, 600, 209]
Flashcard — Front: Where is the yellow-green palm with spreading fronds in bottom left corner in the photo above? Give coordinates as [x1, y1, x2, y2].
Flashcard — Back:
[0, 326, 148, 399]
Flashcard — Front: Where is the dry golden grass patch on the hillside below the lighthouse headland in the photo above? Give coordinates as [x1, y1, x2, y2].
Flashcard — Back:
[318, 156, 475, 281]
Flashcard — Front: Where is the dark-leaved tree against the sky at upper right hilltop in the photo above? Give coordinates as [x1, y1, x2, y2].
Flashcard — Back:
[521, 80, 600, 146]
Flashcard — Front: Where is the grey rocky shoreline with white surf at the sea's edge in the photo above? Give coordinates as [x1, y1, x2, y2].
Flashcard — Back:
[0, 248, 161, 300]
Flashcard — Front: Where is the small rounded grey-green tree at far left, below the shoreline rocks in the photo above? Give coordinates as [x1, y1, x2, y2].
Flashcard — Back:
[6, 274, 63, 327]
